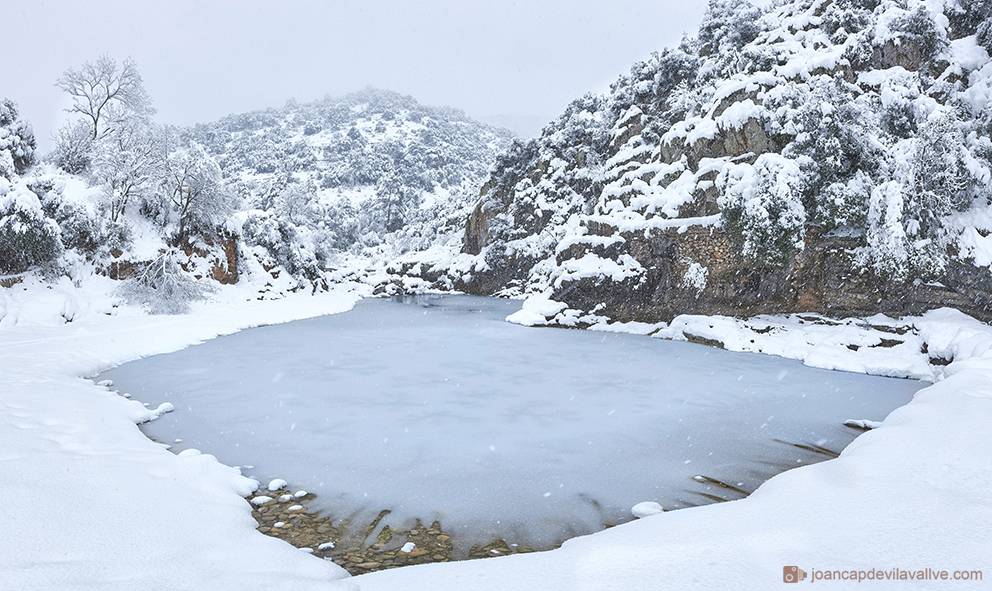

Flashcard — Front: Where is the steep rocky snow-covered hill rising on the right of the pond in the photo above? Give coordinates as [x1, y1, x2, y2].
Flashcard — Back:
[398, 0, 992, 322]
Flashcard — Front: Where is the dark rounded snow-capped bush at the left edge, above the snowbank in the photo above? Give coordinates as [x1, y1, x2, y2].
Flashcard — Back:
[0, 187, 62, 273]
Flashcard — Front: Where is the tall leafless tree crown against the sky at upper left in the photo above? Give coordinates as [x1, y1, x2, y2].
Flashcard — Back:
[55, 54, 155, 140]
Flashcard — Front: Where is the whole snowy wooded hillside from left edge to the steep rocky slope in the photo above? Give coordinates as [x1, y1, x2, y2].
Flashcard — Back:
[0, 90, 512, 311]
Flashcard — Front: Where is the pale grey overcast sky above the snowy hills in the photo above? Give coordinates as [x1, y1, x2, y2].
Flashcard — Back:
[0, 0, 736, 151]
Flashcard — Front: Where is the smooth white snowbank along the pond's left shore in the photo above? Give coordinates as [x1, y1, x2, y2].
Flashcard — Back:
[0, 278, 360, 590]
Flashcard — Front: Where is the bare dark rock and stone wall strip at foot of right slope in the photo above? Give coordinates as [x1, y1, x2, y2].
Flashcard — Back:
[553, 228, 992, 322]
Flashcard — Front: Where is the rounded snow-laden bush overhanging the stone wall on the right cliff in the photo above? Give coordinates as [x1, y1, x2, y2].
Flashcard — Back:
[720, 154, 806, 267]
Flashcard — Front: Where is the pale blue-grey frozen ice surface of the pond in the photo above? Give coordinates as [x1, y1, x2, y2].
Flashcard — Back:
[99, 296, 922, 550]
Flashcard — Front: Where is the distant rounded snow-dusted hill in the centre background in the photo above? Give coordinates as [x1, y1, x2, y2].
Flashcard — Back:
[182, 88, 512, 264]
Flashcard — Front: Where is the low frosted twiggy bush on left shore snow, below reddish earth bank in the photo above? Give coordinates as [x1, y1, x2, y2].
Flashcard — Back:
[116, 249, 213, 314]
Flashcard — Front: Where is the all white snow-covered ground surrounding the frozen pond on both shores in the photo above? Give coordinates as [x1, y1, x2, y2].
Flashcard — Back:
[0, 278, 992, 590]
